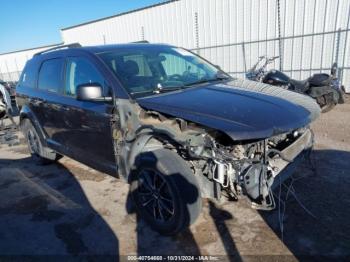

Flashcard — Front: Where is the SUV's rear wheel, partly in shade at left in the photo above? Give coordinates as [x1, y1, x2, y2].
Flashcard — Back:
[21, 119, 61, 165]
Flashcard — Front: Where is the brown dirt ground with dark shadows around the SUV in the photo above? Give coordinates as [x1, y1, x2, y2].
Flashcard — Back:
[0, 98, 350, 260]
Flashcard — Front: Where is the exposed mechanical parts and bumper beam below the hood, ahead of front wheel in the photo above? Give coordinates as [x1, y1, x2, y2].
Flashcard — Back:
[188, 128, 313, 210]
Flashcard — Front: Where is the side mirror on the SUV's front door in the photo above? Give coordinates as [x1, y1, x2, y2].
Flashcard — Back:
[77, 83, 112, 102]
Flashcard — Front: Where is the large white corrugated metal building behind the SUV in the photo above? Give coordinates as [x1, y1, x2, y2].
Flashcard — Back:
[0, 0, 350, 92]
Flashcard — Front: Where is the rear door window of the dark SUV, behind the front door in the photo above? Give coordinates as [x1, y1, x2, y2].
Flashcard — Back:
[38, 58, 64, 93]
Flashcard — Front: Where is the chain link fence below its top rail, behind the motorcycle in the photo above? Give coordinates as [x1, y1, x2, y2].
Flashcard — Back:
[192, 28, 350, 92]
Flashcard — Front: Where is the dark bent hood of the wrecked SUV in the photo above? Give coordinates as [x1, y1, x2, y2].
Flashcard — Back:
[137, 84, 311, 140]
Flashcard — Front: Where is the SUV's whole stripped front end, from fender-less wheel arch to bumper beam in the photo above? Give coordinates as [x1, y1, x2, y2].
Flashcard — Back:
[112, 99, 313, 210]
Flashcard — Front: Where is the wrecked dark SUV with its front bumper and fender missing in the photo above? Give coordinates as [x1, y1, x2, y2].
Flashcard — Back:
[17, 43, 320, 235]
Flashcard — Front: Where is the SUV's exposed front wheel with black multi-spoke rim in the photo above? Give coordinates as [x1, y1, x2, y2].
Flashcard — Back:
[130, 149, 202, 235]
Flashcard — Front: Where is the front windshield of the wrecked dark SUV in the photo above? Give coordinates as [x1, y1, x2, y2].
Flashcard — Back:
[98, 45, 229, 98]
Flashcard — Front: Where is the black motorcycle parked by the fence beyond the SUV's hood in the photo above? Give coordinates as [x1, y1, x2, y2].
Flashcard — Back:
[246, 56, 344, 113]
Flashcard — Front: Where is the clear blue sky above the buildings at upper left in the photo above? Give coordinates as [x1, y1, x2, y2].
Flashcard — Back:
[0, 0, 162, 53]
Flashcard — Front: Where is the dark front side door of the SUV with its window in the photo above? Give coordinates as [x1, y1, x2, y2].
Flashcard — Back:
[59, 57, 116, 174]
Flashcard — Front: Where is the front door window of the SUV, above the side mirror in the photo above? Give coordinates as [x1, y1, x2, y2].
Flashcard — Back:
[66, 57, 104, 96]
